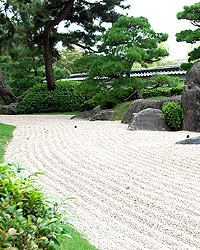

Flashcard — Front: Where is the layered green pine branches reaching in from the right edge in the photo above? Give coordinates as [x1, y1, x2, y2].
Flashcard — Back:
[176, 3, 200, 70]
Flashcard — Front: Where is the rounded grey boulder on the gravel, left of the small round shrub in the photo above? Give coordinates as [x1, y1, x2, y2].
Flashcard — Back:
[128, 108, 170, 131]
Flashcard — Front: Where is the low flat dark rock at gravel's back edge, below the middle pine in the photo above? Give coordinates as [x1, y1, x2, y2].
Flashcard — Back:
[71, 109, 114, 121]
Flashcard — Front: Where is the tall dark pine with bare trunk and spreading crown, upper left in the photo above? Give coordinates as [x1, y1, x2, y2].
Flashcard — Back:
[0, 0, 127, 90]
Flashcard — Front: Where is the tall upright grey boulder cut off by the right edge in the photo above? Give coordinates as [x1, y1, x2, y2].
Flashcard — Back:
[182, 60, 200, 132]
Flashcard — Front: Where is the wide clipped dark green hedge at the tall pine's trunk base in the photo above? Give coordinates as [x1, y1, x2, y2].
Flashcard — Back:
[18, 81, 89, 113]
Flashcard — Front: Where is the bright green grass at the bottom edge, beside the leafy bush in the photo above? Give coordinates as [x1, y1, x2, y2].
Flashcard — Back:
[56, 226, 98, 250]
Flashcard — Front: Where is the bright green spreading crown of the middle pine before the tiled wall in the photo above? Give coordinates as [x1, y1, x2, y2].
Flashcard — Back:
[79, 16, 168, 100]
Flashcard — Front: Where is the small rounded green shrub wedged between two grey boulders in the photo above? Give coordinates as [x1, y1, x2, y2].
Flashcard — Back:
[162, 101, 183, 130]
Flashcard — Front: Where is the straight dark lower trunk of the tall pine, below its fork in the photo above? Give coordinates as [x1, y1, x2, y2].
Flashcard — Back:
[44, 30, 56, 90]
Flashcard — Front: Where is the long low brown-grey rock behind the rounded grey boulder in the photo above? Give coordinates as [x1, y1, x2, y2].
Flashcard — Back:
[122, 96, 181, 124]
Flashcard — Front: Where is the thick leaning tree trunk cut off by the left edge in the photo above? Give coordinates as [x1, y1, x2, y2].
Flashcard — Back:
[0, 69, 17, 105]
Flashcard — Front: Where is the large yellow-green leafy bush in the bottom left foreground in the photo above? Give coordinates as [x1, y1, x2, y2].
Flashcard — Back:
[0, 163, 72, 250]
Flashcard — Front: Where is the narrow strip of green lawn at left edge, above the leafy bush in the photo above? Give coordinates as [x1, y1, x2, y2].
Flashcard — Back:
[0, 123, 15, 163]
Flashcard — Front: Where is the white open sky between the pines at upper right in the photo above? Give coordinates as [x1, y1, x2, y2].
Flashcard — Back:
[126, 0, 199, 60]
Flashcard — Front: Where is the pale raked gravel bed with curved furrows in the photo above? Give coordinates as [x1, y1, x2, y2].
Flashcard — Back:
[0, 115, 200, 250]
